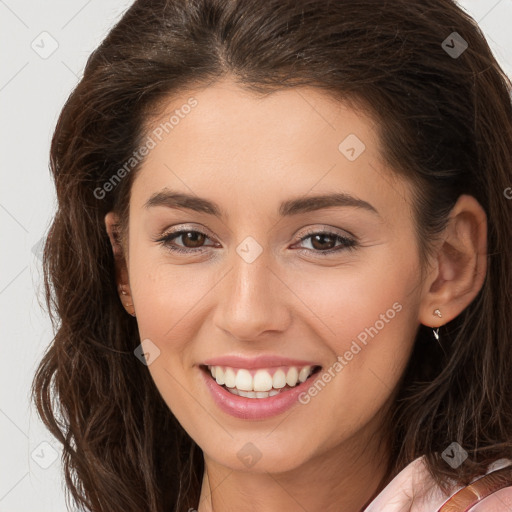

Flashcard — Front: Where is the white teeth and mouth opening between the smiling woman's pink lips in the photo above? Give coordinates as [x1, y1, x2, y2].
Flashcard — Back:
[201, 365, 322, 398]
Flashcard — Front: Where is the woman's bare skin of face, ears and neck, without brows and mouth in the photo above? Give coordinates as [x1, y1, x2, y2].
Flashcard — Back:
[105, 79, 486, 512]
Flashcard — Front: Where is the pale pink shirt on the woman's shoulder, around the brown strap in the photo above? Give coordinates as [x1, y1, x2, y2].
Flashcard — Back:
[364, 456, 512, 512]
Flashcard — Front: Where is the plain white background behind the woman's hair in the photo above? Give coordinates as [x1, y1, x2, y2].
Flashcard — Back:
[0, 0, 512, 512]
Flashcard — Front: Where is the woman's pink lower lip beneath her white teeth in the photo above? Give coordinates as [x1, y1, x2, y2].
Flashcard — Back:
[200, 369, 320, 420]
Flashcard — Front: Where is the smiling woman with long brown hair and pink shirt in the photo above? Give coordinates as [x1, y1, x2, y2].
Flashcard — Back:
[34, 0, 512, 512]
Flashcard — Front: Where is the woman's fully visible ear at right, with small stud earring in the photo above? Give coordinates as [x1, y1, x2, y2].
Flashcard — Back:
[419, 195, 487, 327]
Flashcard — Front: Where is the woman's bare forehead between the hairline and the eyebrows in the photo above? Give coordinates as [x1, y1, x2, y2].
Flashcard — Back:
[132, 81, 407, 222]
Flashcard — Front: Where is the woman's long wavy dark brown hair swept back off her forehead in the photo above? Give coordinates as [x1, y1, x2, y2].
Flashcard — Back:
[33, 0, 512, 512]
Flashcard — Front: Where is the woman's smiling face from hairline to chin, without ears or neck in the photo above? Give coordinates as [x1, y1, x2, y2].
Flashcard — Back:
[118, 81, 421, 471]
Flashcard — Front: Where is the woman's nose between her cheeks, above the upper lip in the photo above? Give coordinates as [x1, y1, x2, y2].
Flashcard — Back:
[214, 245, 293, 341]
